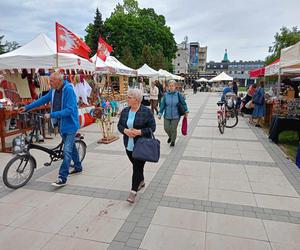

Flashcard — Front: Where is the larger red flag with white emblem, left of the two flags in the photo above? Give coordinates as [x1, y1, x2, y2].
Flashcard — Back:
[56, 23, 91, 60]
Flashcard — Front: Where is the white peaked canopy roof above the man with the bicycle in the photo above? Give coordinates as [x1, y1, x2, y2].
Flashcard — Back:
[0, 34, 95, 71]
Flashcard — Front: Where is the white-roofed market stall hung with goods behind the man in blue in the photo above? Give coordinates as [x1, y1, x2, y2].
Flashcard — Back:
[0, 34, 94, 151]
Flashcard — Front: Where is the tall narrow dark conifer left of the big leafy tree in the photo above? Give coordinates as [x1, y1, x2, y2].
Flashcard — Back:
[84, 8, 105, 55]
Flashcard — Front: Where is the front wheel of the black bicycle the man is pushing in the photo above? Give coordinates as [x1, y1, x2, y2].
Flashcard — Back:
[2, 155, 36, 189]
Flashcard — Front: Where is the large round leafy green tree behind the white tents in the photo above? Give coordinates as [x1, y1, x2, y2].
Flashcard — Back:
[104, 0, 177, 70]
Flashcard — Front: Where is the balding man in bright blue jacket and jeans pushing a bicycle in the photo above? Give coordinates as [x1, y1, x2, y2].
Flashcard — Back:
[19, 72, 82, 187]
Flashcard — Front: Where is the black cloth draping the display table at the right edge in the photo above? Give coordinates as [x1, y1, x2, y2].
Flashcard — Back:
[269, 115, 300, 143]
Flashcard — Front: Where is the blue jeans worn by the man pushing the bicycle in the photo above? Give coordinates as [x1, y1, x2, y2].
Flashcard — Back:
[58, 133, 82, 181]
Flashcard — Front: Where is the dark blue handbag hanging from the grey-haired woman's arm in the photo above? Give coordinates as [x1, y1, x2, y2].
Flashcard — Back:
[132, 132, 160, 162]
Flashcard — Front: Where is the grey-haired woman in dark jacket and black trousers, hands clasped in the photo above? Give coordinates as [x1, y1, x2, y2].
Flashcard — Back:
[118, 89, 156, 203]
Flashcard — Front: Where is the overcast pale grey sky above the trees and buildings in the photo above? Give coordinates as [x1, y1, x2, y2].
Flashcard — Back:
[0, 0, 300, 61]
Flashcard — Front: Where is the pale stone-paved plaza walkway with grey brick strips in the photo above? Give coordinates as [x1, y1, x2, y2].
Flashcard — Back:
[0, 93, 300, 250]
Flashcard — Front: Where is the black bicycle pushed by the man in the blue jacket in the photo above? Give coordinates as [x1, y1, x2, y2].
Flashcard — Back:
[2, 113, 87, 189]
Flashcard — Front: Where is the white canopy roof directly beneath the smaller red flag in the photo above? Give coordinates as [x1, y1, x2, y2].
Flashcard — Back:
[91, 54, 137, 76]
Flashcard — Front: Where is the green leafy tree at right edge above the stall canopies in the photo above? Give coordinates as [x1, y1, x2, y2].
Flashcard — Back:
[265, 27, 300, 65]
